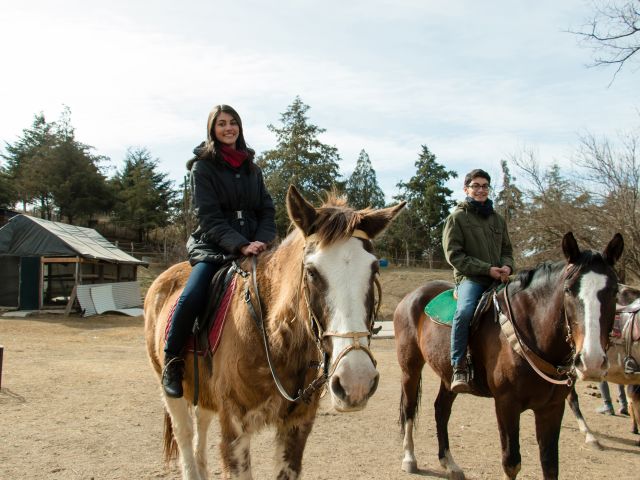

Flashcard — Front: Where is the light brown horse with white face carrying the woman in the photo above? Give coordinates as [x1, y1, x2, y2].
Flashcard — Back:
[144, 187, 404, 480]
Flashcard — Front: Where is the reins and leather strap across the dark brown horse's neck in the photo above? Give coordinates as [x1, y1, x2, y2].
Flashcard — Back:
[493, 284, 575, 387]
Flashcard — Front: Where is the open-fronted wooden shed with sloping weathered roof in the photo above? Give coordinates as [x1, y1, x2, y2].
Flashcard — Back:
[0, 215, 148, 311]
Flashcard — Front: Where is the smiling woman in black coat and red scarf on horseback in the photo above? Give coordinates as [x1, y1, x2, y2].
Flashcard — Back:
[162, 105, 276, 398]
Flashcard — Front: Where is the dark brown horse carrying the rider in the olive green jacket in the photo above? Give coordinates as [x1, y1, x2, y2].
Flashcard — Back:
[393, 233, 623, 479]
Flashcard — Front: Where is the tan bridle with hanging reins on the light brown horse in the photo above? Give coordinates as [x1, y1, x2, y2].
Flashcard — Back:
[240, 229, 382, 403]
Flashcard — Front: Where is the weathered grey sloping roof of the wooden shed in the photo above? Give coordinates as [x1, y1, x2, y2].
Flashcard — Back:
[0, 215, 148, 265]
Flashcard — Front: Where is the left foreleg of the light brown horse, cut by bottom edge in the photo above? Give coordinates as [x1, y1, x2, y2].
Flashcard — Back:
[220, 414, 253, 480]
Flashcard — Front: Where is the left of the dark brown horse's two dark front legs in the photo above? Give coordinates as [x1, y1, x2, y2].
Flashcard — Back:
[495, 398, 522, 480]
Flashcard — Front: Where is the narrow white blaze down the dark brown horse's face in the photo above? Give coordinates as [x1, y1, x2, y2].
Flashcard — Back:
[578, 272, 607, 377]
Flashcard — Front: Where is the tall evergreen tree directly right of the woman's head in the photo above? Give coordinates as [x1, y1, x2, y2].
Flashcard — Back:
[257, 97, 340, 236]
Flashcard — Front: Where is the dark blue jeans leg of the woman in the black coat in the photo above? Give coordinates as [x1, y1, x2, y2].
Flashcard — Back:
[164, 262, 220, 357]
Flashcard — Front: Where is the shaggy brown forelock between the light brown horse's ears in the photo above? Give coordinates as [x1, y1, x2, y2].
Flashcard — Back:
[312, 192, 371, 248]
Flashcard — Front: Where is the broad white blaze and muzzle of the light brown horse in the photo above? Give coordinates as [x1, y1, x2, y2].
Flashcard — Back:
[308, 238, 378, 409]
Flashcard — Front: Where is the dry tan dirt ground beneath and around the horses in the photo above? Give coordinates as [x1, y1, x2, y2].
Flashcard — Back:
[0, 271, 640, 480]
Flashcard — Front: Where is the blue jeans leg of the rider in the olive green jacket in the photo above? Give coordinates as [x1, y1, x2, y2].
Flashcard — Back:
[451, 280, 487, 366]
